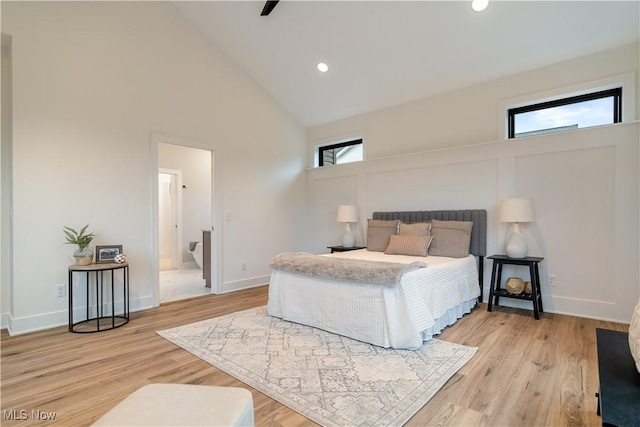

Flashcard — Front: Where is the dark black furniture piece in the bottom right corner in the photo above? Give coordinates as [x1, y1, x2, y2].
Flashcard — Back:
[596, 328, 640, 427]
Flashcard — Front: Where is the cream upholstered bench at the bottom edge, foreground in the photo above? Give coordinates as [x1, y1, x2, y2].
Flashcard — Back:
[93, 384, 253, 427]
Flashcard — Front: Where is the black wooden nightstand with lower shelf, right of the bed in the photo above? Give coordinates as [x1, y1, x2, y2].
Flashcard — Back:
[487, 255, 544, 320]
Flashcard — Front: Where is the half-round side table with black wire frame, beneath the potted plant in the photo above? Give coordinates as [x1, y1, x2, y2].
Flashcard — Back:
[69, 262, 129, 334]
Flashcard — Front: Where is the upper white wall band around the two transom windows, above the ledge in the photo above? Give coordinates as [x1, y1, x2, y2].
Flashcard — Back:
[307, 43, 640, 167]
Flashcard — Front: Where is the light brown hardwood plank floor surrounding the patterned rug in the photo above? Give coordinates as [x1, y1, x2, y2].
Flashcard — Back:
[0, 286, 628, 426]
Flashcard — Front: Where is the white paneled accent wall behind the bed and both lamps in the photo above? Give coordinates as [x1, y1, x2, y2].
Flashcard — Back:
[307, 122, 640, 322]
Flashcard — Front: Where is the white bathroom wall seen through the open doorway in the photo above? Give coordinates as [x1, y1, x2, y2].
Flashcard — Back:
[158, 143, 213, 262]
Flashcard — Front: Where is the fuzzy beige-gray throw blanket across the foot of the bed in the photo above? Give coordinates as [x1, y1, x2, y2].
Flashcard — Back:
[269, 252, 427, 286]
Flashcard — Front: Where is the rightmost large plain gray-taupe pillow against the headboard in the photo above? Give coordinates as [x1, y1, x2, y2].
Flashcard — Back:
[429, 219, 473, 258]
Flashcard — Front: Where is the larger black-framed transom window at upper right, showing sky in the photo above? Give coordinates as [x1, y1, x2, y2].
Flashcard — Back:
[507, 88, 622, 138]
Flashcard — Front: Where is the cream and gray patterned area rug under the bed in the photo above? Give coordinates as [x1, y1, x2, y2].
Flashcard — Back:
[157, 307, 477, 426]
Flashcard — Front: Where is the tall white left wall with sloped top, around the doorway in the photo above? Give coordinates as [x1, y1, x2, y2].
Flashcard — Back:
[1, 2, 306, 333]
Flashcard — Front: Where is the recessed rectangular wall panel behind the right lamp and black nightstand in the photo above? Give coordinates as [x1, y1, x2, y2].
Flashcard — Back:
[515, 146, 616, 310]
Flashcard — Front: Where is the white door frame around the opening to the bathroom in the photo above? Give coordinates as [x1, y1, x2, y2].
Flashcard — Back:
[150, 131, 222, 307]
